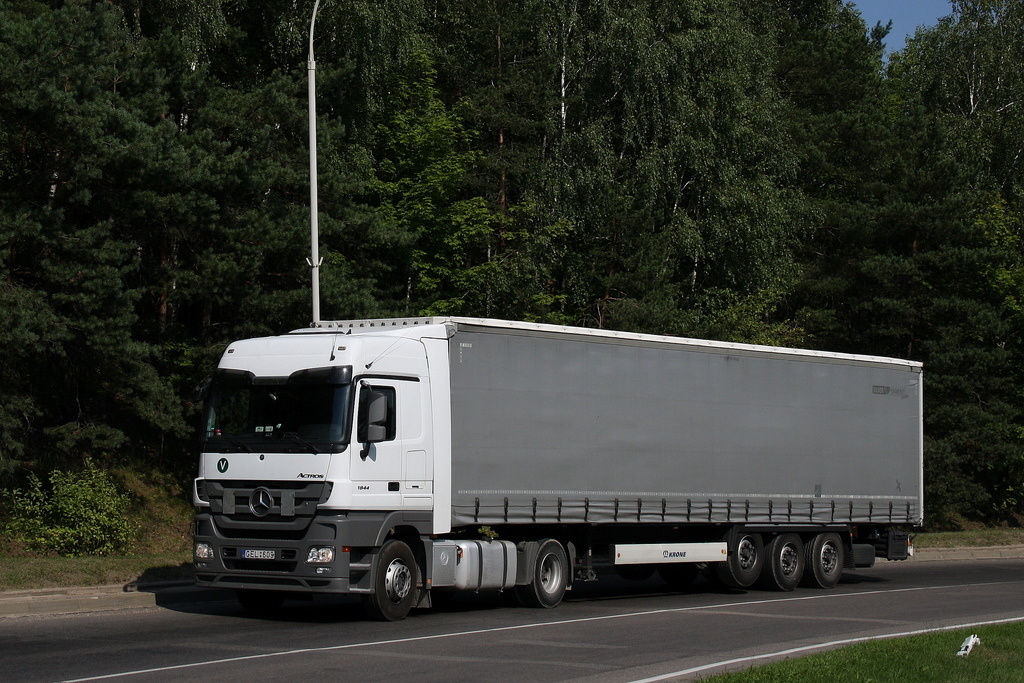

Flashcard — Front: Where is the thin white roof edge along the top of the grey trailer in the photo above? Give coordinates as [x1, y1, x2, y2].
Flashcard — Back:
[291, 316, 923, 371]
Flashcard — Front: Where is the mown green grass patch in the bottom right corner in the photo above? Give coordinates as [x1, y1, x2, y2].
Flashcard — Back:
[703, 624, 1024, 683]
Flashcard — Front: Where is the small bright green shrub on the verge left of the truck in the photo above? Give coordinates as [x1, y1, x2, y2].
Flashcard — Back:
[9, 463, 138, 557]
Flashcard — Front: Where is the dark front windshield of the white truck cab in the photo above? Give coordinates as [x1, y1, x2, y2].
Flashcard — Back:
[202, 380, 351, 453]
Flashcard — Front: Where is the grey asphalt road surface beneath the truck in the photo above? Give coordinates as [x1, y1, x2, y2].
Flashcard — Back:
[0, 559, 1024, 683]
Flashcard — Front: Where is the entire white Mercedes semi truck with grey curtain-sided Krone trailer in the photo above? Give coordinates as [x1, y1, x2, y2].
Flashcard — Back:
[194, 317, 923, 620]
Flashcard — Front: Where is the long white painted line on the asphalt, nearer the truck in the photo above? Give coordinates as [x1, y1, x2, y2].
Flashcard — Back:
[63, 581, 1021, 683]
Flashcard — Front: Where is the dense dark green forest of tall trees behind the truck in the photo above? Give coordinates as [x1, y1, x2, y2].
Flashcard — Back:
[0, 0, 1024, 552]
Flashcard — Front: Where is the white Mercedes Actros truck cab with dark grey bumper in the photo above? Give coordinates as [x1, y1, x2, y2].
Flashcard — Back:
[194, 323, 446, 618]
